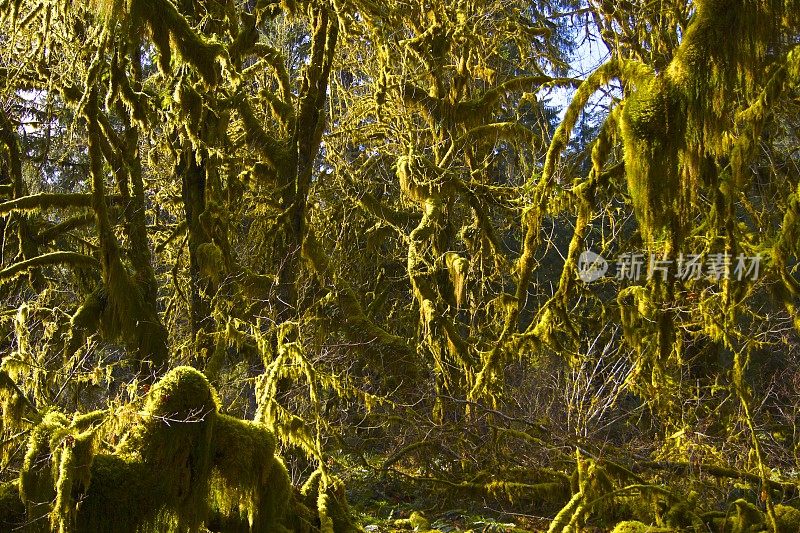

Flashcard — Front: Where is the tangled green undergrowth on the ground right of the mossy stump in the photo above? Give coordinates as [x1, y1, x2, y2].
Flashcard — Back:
[346, 458, 800, 533]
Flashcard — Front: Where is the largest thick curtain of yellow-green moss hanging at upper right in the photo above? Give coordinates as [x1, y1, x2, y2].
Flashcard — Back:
[621, 0, 792, 245]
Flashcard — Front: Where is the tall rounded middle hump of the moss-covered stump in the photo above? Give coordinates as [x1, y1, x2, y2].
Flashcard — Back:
[72, 367, 218, 531]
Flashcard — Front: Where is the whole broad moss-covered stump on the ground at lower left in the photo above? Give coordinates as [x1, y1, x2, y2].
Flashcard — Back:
[8, 367, 356, 533]
